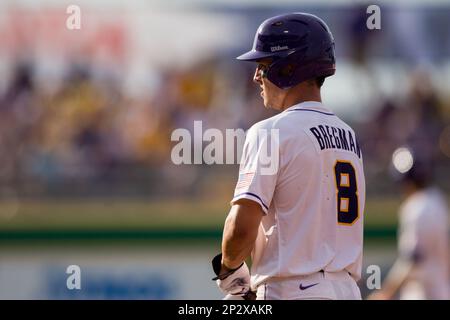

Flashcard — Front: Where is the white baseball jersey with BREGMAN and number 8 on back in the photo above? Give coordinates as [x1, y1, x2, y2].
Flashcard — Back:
[231, 101, 365, 289]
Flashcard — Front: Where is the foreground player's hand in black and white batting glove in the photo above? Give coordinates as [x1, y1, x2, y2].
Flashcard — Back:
[212, 253, 250, 300]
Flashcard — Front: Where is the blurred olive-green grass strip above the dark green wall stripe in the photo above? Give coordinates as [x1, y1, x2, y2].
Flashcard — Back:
[0, 198, 399, 230]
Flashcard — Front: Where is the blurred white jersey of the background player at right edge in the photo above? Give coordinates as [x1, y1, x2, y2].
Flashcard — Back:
[398, 188, 450, 300]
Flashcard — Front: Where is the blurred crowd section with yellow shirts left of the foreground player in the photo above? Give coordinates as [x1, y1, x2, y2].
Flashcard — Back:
[0, 60, 278, 195]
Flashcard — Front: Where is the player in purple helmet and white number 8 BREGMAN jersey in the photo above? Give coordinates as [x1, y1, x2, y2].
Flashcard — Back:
[212, 13, 365, 300]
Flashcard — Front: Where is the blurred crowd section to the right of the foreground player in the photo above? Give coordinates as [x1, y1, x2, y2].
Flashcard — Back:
[358, 69, 450, 192]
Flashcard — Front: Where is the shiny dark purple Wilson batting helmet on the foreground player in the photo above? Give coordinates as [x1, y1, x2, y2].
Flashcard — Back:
[237, 12, 336, 89]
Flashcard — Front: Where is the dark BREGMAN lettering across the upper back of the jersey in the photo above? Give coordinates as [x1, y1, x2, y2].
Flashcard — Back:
[309, 125, 361, 158]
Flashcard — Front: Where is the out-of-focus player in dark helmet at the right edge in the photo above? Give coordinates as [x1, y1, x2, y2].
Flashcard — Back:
[368, 148, 450, 300]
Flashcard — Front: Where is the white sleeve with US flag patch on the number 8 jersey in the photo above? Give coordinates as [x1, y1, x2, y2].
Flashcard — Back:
[231, 127, 280, 214]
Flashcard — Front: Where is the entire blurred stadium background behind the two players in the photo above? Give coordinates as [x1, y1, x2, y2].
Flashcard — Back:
[0, 0, 450, 299]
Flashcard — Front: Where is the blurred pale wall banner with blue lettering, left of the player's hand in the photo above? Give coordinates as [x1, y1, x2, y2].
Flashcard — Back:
[0, 246, 222, 300]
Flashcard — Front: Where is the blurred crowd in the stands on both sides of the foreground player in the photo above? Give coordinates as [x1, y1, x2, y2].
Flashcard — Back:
[0, 59, 450, 199]
